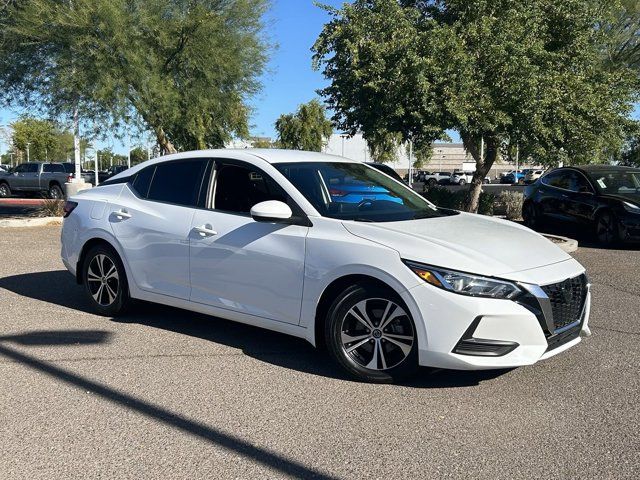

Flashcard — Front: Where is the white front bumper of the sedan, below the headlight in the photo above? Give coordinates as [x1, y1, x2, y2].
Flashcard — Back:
[403, 264, 591, 370]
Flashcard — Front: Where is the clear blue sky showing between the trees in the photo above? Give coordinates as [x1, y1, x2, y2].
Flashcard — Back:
[0, 0, 343, 153]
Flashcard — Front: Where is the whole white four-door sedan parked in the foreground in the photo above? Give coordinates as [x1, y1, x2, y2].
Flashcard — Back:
[61, 150, 590, 382]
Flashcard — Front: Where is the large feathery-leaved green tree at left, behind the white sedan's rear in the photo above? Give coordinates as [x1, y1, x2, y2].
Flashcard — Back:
[0, 0, 269, 153]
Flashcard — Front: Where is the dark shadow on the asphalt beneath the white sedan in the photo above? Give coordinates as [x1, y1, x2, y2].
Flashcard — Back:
[0, 270, 507, 389]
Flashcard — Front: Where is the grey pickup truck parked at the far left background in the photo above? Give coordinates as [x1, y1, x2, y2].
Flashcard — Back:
[0, 162, 69, 199]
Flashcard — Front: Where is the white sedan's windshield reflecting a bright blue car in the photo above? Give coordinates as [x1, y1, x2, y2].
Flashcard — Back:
[274, 162, 454, 222]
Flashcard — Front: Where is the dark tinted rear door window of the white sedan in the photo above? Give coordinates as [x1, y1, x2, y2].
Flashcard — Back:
[147, 159, 208, 207]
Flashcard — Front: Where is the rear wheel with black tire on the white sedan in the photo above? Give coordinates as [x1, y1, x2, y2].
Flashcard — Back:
[82, 244, 131, 317]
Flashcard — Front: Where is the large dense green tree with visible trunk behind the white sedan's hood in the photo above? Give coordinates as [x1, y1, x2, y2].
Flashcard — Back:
[313, 0, 637, 211]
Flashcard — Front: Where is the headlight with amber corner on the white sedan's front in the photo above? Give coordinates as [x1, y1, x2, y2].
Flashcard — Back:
[404, 261, 522, 299]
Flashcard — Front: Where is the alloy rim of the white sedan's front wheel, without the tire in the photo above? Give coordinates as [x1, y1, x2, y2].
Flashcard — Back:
[340, 298, 415, 370]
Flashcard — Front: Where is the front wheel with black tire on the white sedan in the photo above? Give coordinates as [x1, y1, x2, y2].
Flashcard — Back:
[325, 283, 418, 383]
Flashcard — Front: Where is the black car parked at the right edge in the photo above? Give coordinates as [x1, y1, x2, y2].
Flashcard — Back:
[522, 165, 640, 246]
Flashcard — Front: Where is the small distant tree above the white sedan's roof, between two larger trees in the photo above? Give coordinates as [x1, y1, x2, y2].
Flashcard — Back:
[275, 100, 333, 152]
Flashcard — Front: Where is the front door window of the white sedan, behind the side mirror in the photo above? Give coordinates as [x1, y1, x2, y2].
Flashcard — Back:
[213, 164, 296, 214]
